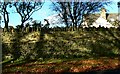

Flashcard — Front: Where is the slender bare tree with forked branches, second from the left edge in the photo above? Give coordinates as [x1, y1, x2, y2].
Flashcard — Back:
[13, 2, 43, 28]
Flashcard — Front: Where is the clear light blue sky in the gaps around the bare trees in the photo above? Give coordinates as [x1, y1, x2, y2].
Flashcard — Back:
[1, 0, 118, 27]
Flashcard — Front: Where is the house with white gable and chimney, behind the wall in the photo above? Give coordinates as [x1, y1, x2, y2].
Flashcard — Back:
[82, 8, 119, 28]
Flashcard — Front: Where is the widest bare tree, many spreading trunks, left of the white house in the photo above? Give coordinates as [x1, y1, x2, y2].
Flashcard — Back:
[51, 0, 111, 29]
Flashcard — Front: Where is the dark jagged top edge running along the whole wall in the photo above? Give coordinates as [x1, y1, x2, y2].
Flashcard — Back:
[2, 26, 120, 33]
